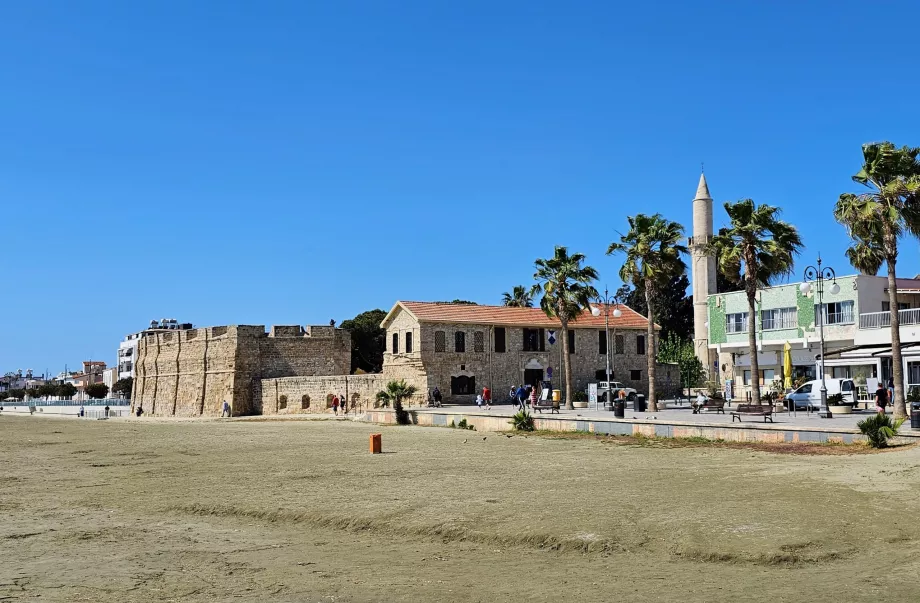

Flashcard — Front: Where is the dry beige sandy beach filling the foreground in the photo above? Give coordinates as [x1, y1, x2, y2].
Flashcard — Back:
[0, 416, 920, 603]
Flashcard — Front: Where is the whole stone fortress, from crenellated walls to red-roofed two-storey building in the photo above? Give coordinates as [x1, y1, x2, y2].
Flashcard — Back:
[131, 302, 678, 417]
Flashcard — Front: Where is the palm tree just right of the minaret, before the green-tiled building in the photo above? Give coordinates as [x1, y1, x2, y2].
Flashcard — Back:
[709, 199, 802, 404]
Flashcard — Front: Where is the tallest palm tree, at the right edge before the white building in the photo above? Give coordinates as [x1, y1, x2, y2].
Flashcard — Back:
[834, 142, 920, 417]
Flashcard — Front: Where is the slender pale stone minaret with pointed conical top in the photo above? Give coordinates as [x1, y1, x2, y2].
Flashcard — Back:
[690, 174, 716, 378]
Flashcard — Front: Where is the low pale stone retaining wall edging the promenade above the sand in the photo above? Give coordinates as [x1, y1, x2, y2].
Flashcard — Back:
[360, 410, 884, 444]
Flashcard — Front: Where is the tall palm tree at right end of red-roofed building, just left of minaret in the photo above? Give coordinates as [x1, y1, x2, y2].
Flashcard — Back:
[607, 214, 688, 412]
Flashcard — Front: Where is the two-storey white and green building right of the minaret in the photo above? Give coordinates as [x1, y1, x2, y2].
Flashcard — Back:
[707, 275, 920, 397]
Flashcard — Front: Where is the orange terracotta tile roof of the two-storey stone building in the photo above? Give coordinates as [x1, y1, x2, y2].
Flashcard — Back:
[396, 301, 648, 329]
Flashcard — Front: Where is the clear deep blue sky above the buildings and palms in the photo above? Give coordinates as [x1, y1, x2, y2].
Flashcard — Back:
[0, 0, 920, 372]
